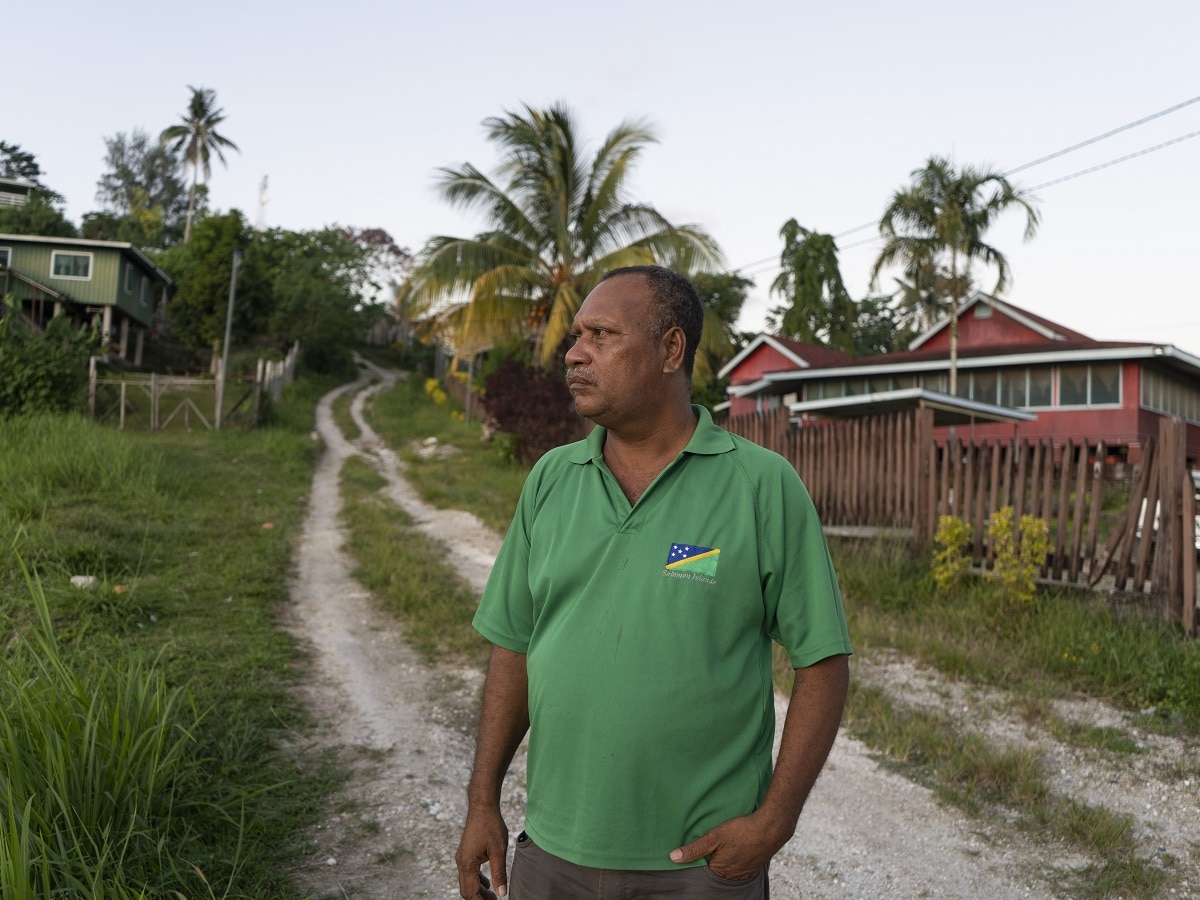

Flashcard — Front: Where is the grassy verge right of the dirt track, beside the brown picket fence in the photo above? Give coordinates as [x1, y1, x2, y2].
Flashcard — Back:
[350, 372, 1200, 896]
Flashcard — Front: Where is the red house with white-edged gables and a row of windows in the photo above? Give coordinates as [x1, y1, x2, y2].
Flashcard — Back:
[721, 293, 1200, 462]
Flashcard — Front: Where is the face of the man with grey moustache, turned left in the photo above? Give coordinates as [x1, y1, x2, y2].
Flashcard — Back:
[566, 275, 664, 427]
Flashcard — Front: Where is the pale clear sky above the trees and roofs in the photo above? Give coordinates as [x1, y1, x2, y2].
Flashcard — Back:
[9, 0, 1200, 355]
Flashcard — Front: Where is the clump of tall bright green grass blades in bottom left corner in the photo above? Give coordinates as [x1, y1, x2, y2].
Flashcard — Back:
[0, 566, 223, 898]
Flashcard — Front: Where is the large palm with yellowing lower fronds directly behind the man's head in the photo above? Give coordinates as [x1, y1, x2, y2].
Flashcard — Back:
[397, 104, 721, 365]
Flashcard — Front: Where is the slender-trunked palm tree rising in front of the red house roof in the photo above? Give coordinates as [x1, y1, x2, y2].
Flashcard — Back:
[871, 156, 1039, 394]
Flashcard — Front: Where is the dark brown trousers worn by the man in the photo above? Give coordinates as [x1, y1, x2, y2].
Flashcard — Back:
[509, 832, 770, 900]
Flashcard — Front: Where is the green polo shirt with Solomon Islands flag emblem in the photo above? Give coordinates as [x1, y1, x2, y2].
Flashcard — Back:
[474, 407, 851, 869]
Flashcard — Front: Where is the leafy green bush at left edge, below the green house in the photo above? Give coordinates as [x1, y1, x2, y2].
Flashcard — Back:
[0, 296, 100, 416]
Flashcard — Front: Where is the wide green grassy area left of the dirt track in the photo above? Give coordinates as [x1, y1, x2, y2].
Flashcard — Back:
[0, 379, 348, 898]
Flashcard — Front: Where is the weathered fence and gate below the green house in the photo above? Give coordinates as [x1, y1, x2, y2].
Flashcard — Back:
[88, 342, 300, 431]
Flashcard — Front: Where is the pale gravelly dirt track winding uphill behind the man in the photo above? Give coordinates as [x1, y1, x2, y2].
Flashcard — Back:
[280, 367, 1200, 900]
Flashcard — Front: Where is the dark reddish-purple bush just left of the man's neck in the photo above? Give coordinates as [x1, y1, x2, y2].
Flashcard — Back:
[484, 358, 583, 464]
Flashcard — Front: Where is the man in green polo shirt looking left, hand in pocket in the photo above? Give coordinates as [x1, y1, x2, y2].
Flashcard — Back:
[457, 266, 851, 900]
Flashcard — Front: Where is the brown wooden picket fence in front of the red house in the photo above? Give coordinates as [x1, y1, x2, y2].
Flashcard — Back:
[725, 409, 1198, 634]
